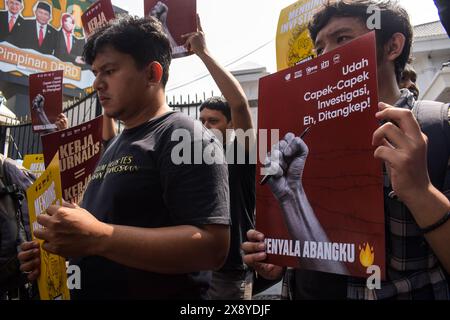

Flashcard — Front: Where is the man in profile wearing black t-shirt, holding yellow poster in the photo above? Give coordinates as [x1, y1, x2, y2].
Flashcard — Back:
[19, 17, 230, 299]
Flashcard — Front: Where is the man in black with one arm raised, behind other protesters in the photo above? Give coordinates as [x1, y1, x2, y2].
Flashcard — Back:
[184, 19, 256, 300]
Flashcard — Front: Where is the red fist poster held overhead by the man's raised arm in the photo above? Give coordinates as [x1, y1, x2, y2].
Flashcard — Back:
[144, 0, 197, 58]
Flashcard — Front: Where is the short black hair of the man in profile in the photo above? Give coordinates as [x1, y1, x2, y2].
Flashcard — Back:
[83, 15, 172, 86]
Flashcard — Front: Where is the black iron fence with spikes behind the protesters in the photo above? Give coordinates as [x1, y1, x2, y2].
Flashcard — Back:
[0, 93, 206, 159]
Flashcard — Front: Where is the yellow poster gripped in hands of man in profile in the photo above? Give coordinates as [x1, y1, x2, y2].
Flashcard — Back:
[27, 155, 70, 300]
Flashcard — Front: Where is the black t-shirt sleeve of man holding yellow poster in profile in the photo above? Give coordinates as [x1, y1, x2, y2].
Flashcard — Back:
[160, 120, 230, 225]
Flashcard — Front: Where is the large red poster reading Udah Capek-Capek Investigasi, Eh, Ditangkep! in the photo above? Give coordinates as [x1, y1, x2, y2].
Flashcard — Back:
[256, 33, 385, 278]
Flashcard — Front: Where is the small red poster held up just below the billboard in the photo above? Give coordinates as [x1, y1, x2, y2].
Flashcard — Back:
[29, 70, 63, 132]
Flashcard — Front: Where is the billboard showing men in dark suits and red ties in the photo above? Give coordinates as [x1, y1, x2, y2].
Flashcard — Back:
[0, 0, 94, 89]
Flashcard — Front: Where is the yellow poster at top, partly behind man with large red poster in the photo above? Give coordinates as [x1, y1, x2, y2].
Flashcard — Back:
[276, 0, 326, 70]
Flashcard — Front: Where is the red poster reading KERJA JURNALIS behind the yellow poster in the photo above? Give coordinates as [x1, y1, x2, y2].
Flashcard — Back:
[42, 116, 103, 203]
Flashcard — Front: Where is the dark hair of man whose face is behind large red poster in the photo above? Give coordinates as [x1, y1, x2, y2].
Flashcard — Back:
[309, 0, 413, 81]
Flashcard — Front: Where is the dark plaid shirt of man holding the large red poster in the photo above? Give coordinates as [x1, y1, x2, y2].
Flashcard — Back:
[282, 90, 450, 300]
